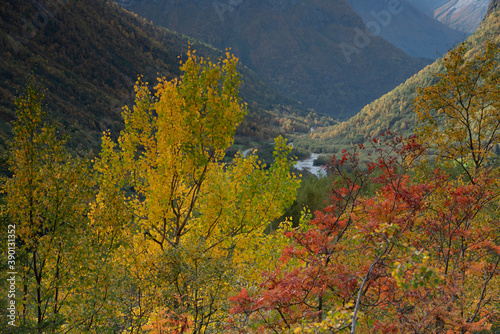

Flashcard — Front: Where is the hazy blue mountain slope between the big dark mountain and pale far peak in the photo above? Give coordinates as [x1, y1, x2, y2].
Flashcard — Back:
[348, 0, 467, 59]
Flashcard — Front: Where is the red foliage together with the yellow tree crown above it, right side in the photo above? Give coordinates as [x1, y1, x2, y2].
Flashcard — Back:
[229, 44, 500, 333]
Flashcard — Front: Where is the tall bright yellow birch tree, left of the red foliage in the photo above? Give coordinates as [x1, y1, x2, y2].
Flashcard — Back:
[91, 50, 299, 333]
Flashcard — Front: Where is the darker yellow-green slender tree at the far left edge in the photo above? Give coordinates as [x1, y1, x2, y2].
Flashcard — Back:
[1, 84, 114, 333]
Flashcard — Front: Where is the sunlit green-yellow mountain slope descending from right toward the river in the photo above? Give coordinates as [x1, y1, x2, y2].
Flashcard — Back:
[300, 0, 500, 153]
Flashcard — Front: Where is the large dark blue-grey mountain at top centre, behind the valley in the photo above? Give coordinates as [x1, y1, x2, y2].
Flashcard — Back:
[112, 0, 429, 119]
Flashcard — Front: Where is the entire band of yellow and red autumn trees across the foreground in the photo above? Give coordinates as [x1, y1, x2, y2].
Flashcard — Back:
[0, 38, 500, 334]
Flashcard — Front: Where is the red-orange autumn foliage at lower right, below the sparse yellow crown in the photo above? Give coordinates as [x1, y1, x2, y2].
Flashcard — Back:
[232, 133, 500, 333]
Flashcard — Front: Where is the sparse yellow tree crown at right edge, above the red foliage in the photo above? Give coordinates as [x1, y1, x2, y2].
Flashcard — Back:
[415, 42, 500, 183]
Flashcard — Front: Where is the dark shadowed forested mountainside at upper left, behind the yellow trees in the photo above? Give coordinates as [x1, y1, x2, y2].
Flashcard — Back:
[0, 0, 324, 150]
